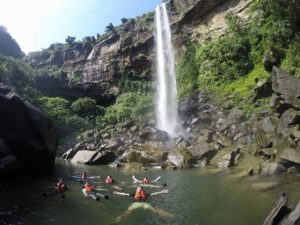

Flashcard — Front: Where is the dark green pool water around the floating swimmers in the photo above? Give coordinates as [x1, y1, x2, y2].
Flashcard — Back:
[0, 160, 300, 225]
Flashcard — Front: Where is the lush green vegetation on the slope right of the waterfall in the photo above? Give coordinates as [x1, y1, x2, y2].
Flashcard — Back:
[176, 0, 300, 112]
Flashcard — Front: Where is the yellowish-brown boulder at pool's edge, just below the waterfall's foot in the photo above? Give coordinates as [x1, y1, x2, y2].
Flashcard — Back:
[168, 149, 192, 168]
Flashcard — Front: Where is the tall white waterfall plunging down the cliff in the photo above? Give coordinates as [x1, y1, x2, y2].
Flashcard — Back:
[155, 3, 178, 136]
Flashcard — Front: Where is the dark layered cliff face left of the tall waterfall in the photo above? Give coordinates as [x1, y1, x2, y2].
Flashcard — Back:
[25, 13, 154, 105]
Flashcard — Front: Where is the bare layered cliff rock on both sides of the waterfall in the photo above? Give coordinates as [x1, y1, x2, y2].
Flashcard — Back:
[27, 0, 251, 105]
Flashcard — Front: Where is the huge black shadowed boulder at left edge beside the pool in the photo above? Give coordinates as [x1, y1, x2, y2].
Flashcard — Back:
[0, 84, 57, 173]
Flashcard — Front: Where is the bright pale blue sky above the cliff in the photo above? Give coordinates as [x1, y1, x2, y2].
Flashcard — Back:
[0, 0, 161, 53]
